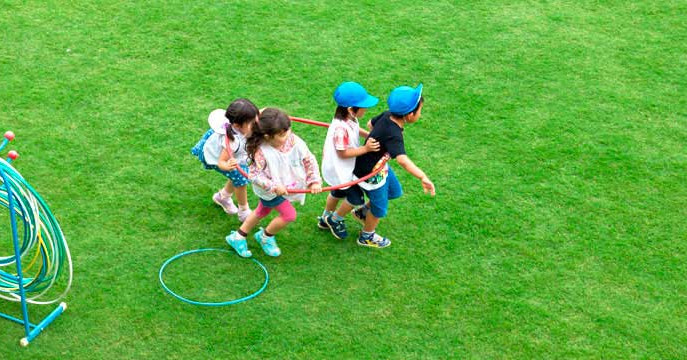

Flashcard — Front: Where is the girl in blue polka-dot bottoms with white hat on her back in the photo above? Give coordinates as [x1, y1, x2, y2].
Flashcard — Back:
[191, 99, 258, 222]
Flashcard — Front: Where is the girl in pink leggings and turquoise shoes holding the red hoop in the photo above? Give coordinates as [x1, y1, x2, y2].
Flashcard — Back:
[226, 108, 322, 257]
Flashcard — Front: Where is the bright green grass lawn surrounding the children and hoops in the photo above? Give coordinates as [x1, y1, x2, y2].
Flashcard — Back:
[0, 0, 687, 359]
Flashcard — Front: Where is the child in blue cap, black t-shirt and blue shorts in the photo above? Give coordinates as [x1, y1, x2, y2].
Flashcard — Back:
[353, 84, 435, 248]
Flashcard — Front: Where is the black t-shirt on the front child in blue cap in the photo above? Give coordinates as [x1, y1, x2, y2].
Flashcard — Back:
[353, 111, 406, 178]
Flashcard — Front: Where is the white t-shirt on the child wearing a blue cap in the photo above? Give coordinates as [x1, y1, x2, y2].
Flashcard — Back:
[322, 118, 360, 186]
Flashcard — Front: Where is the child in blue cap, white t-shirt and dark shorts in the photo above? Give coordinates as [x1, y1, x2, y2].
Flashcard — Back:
[317, 82, 379, 239]
